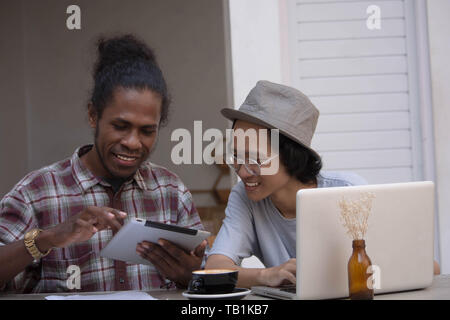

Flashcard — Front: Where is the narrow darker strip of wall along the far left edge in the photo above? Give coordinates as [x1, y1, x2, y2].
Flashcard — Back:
[0, 1, 28, 197]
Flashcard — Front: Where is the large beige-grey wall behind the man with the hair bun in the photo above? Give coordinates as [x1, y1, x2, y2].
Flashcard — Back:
[0, 0, 229, 205]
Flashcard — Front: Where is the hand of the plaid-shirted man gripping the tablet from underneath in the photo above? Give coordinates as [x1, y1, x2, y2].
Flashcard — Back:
[136, 239, 207, 287]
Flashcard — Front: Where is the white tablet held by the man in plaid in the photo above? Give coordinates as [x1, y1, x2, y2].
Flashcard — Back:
[100, 219, 211, 265]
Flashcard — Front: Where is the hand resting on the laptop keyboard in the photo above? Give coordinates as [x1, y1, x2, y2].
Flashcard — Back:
[260, 258, 297, 287]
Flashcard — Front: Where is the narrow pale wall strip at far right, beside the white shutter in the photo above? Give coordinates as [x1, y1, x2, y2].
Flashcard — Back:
[427, 0, 450, 274]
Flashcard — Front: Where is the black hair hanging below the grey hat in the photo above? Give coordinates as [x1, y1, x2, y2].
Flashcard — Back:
[279, 133, 322, 183]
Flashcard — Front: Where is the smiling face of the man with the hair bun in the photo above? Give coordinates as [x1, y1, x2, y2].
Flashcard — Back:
[82, 88, 162, 178]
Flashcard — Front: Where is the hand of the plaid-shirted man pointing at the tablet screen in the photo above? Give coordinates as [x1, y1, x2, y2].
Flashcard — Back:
[46, 206, 127, 248]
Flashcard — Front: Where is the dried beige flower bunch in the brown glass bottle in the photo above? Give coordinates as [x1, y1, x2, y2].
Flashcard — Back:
[339, 192, 375, 240]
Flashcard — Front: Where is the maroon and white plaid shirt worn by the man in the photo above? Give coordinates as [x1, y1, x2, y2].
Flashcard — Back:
[0, 145, 203, 293]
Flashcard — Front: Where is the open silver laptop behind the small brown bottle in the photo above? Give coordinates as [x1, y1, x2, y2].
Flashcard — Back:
[252, 181, 434, 299]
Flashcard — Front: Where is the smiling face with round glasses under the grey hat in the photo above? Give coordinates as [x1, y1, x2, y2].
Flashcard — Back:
[233, 120, 291, 201]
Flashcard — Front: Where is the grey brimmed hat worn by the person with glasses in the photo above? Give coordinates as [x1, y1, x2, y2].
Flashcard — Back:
[221, 80, 320, 159]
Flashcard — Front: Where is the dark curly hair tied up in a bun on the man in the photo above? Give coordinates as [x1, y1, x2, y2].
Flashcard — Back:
[91, 34, 170, 125]
